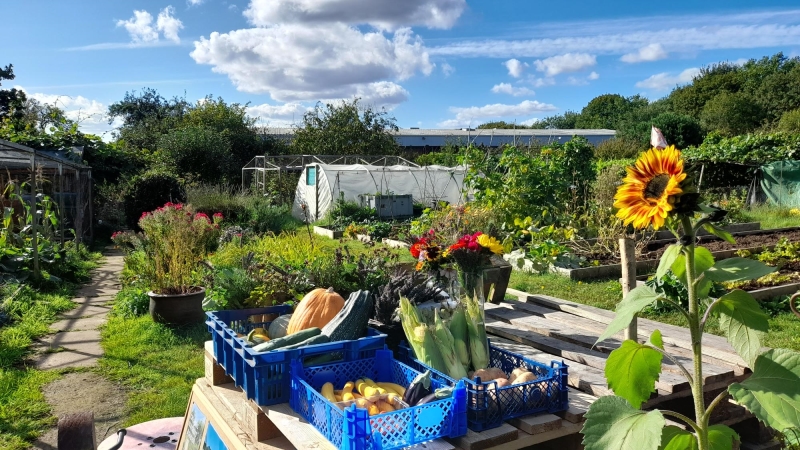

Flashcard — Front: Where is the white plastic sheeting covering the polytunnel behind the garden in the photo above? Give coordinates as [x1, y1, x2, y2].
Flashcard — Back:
[292, 164, 466, 221]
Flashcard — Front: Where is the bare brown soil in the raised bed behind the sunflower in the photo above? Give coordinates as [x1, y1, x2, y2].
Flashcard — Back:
[578, 230, 800, 265]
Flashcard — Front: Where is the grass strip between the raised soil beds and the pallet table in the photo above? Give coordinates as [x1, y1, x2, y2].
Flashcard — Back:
[509, 272, 800, 351]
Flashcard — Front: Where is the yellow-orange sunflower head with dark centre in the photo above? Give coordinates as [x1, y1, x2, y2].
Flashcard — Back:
[614, 145, 686, 229]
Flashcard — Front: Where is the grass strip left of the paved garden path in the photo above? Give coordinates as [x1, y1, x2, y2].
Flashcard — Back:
[0, 250, 99, 450]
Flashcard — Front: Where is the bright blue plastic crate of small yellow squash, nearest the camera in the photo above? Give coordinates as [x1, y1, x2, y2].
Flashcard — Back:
[289, 350, 467, 450]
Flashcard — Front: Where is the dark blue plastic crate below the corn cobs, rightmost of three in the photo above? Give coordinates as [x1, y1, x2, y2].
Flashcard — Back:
[398, 342, 569, 432]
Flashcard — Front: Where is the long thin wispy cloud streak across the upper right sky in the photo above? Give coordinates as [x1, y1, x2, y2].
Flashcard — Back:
[429, 9, 800, 58]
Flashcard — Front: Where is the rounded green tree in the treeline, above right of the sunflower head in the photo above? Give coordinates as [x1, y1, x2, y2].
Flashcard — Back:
[700, 91, 764, 136]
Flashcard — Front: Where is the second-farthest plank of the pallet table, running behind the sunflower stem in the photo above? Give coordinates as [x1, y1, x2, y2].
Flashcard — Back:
[494, 302, 743, 383]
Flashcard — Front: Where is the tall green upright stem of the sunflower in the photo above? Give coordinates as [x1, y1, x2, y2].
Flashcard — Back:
[681, 217, 709, 450]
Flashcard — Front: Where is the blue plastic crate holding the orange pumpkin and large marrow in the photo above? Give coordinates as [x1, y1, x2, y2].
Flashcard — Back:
[206, 305, 386, 406]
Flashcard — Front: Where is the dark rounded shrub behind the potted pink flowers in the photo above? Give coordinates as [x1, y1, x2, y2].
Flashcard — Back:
[123, 171, 186, 229]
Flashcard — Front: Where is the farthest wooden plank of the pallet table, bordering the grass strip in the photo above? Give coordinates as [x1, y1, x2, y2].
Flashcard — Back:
[507, 289, 747, 368]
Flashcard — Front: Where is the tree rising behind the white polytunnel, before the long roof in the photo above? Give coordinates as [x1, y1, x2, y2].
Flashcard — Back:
[291, 98, 398, 155]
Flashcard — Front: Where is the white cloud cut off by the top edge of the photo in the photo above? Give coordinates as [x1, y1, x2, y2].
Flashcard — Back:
[244, 0, 467, 30]
